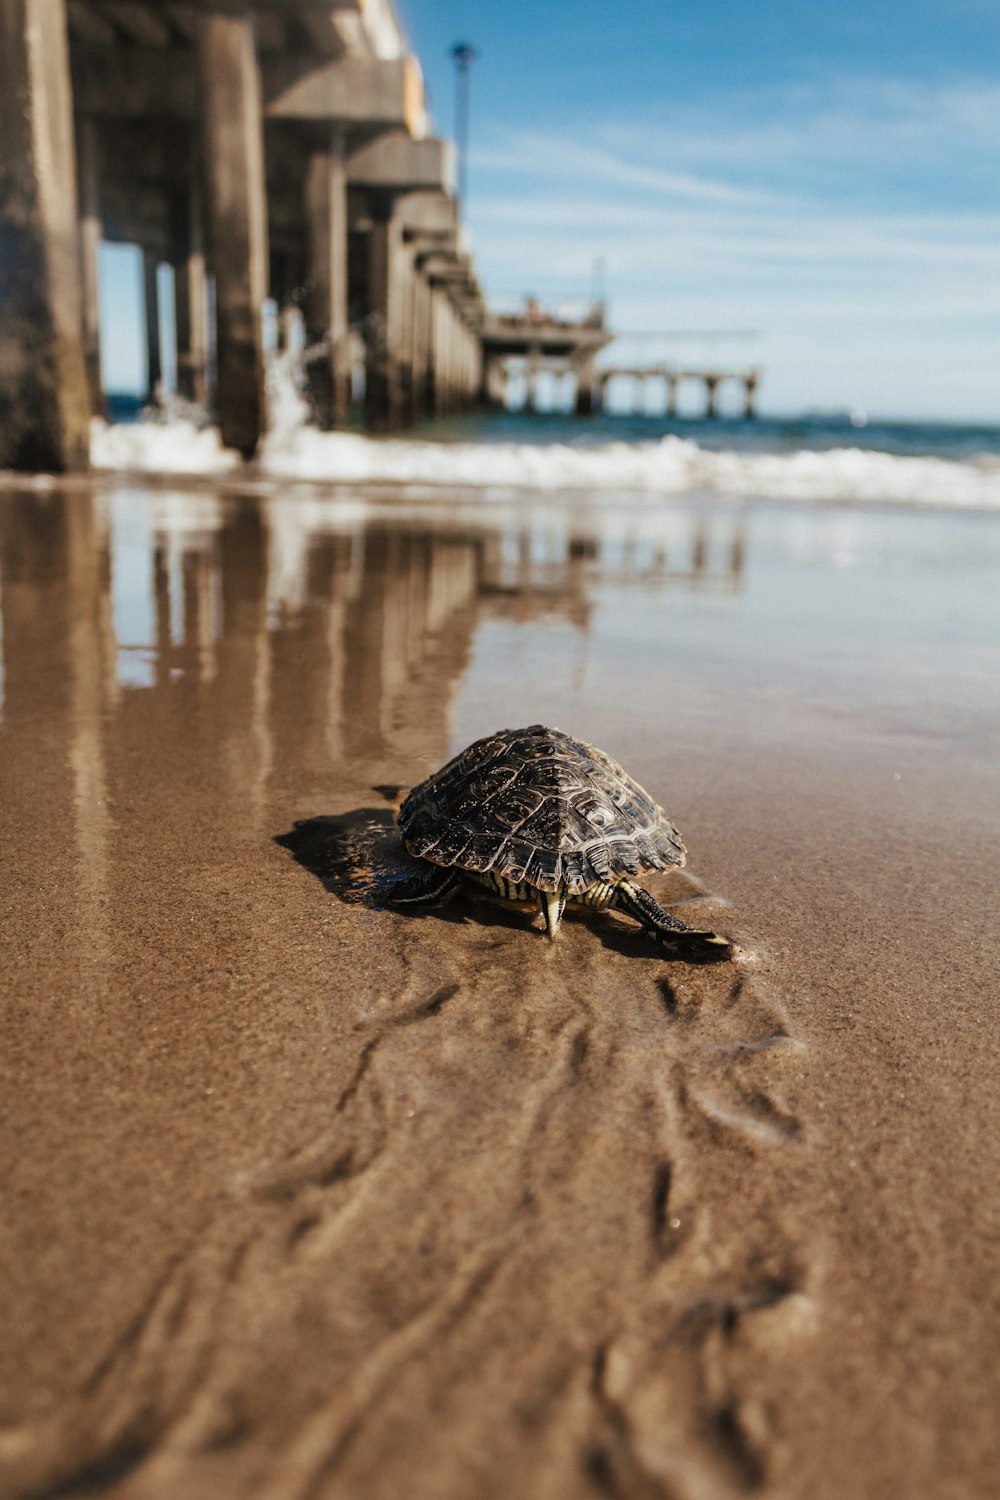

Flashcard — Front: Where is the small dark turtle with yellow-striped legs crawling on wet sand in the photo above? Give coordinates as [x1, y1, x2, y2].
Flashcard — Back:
[388, 725, 732, 959]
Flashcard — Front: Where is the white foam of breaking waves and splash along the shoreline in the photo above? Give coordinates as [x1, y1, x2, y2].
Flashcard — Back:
[91, 360, 1000, 510]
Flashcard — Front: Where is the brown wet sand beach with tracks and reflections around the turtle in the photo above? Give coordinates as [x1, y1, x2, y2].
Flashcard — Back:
[0, 480, 1000, 1500]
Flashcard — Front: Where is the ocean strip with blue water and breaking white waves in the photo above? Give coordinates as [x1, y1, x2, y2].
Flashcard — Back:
[93, 375, 1000, 510]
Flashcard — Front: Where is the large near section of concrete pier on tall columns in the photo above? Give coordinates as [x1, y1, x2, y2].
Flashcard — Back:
[0, 0, 486, 470]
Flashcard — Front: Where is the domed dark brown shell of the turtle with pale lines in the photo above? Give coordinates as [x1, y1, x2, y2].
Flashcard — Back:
[399, 725, 685, 896]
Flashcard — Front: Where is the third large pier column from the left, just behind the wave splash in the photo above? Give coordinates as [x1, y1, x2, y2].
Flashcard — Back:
[304, 125, 351, 428]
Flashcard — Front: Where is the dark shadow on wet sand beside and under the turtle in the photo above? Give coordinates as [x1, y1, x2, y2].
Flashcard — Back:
[274, 816, 727, 963]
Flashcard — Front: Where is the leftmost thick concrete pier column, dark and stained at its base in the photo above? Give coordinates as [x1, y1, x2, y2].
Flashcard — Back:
[0, 0, 90, 471]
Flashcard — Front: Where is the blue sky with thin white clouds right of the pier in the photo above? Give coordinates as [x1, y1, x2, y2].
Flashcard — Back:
[399, 0, 1000, 422]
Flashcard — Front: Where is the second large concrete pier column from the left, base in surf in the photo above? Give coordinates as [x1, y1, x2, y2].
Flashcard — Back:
[198, 9, 267, 458]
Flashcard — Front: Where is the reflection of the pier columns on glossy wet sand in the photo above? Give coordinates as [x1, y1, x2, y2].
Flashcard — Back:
[0, 489, 744, 774]
